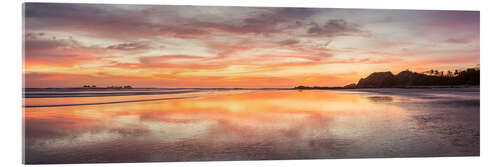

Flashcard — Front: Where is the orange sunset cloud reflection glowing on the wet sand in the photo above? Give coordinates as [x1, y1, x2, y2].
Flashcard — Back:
[24, 90, 474, 163]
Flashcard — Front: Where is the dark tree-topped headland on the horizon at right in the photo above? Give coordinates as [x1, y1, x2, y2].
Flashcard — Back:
[294, 68, 480, 89]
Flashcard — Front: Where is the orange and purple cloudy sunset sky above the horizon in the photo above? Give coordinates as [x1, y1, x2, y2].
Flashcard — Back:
[23, 3, 480, 88]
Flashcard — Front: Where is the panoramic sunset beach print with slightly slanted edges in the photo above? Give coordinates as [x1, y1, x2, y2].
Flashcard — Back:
[22, 3, 480, 164]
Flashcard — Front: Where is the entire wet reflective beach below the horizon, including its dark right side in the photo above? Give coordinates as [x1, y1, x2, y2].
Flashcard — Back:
[23, 88, 480, 164]
